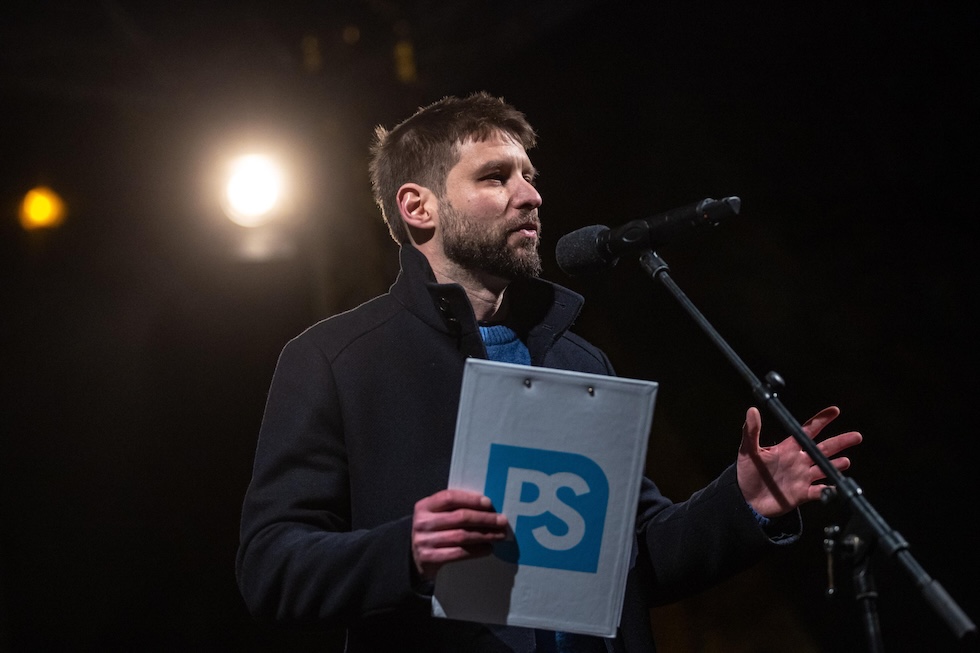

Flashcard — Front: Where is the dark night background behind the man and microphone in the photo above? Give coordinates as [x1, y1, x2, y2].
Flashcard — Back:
[0, 0, 980, 653]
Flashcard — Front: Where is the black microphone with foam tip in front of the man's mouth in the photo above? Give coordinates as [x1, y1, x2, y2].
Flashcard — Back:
[555, 197, 742, 277]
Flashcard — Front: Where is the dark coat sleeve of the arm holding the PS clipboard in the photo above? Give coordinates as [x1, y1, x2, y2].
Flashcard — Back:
[236, 337, 429, 625]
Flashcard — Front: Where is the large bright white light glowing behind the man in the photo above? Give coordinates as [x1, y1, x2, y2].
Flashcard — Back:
[225, 154, 282, 227]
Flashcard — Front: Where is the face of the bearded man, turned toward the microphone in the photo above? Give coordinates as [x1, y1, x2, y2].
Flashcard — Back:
[439, 134, 541, 281]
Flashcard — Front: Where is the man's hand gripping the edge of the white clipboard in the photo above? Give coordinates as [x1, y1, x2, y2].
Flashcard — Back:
[412, 490, 508, 581]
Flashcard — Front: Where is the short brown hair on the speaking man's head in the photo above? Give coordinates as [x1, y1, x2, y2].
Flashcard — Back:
[370, 91, 537, 245]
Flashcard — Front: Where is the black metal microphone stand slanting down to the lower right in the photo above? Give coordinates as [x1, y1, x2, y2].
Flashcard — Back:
[640, 249, 977, 653]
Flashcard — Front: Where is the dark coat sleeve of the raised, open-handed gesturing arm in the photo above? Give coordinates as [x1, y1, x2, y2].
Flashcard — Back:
[636, 465, 802, 605]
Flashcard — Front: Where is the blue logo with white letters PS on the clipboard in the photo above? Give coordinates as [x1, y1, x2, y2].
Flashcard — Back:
[484, 444, 609, 573]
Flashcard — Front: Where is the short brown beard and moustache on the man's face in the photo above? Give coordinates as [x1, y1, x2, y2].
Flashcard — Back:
[441, 201, 541, 281]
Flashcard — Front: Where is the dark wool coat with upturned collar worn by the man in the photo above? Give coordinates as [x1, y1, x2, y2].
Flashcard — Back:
[237, 246, 798, 653]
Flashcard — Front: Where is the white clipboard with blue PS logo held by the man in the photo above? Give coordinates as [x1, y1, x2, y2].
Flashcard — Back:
[432, 359, 657, 637]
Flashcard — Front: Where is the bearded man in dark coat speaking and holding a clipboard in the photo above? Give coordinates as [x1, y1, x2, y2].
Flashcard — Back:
[237, 93, 861, 652]
